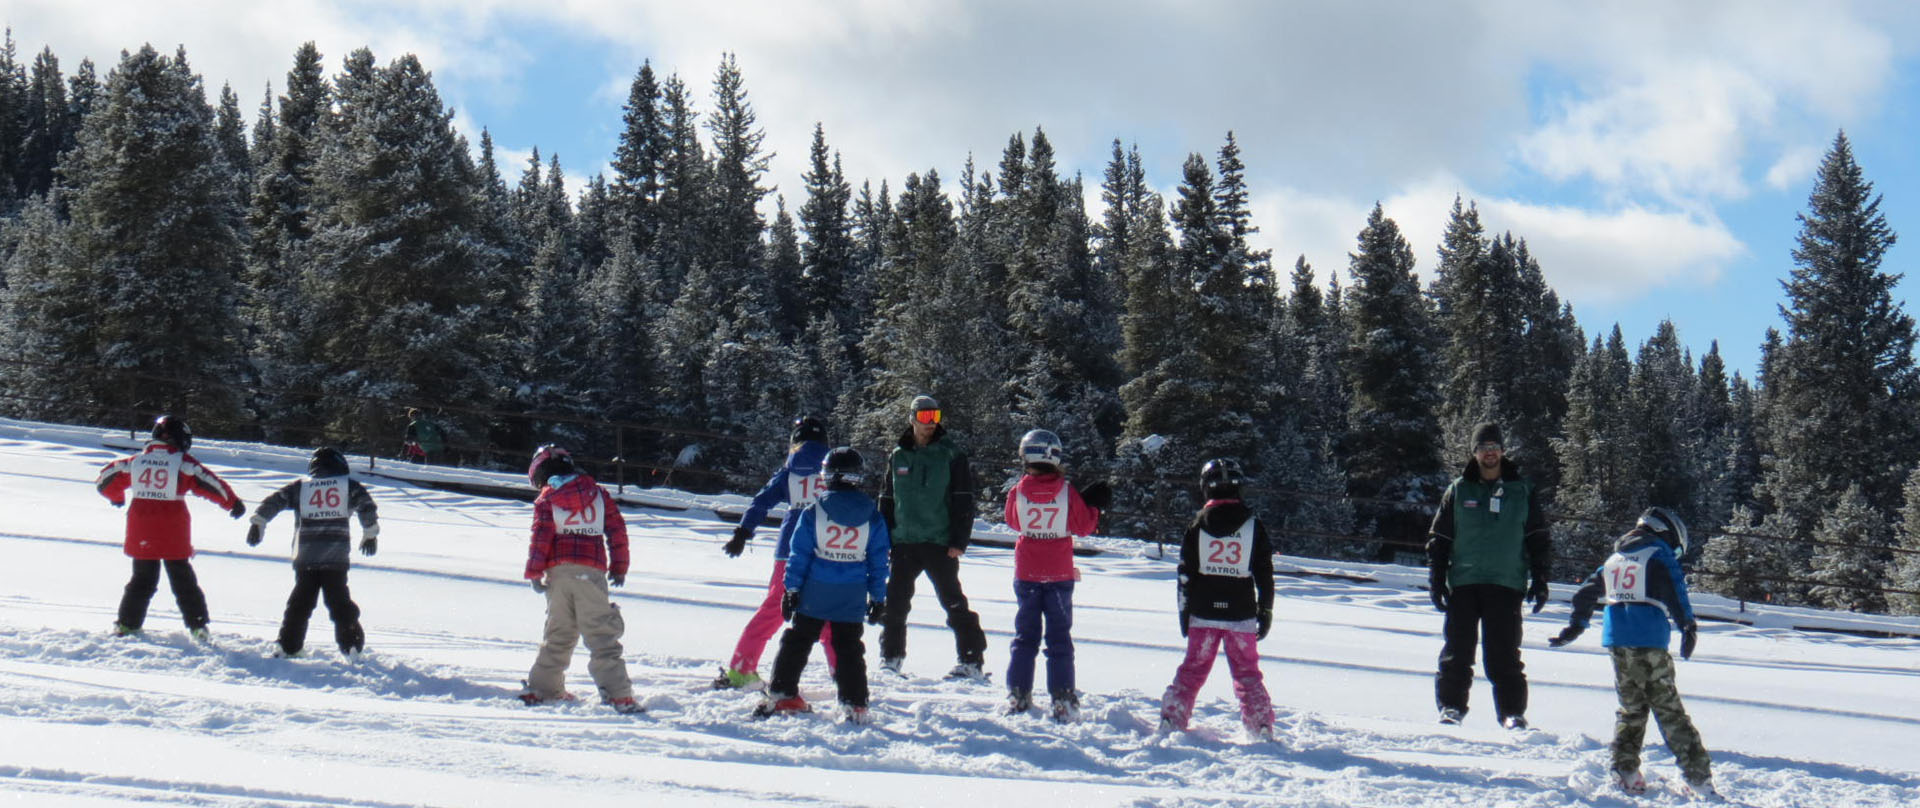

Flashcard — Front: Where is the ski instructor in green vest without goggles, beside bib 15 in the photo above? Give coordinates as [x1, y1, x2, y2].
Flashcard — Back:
[1427, 424, 1553, 729]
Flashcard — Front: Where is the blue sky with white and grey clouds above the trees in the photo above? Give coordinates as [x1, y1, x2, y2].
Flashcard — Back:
[15, 0, 1920, 374]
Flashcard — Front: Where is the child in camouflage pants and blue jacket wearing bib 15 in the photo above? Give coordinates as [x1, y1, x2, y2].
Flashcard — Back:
[1548, 507, 1718, 798]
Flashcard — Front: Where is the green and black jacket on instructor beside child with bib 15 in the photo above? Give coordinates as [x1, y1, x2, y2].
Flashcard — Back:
[1427, 459, 1553, 591]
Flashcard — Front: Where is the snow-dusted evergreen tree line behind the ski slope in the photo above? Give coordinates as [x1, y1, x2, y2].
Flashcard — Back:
[0, 35, 1920, 612]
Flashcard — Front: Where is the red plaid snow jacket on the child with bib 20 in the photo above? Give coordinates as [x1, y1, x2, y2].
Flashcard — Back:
[526, 474, 628, 582]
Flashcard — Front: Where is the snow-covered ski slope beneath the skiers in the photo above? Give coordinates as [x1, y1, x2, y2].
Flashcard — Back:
[0, 422, 1920, 806]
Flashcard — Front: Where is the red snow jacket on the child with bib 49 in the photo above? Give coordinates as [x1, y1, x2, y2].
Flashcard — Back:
[94, 441, 240, 560]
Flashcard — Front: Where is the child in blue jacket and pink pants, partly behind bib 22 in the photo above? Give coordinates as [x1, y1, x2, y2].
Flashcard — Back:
[714, 415, 835, 689]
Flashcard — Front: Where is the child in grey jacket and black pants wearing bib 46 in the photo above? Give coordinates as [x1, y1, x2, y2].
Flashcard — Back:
[246, 447, 380, 656]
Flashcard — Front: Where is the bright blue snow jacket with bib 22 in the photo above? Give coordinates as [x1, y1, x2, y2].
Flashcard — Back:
[787, 487, 893, 624]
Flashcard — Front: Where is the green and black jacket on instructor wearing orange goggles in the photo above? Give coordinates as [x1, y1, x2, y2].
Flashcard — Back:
[879, 426, 973, 549]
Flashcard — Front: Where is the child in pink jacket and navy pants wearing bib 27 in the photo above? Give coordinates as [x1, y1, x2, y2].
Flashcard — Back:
[1006, 430, 1114, 724]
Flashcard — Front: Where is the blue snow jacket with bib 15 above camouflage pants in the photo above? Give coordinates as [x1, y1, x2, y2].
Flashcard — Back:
[1571, 530, 1693, 649]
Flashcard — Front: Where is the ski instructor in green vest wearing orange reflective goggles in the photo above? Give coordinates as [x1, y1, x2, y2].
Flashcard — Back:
[879, 395, 987, 679]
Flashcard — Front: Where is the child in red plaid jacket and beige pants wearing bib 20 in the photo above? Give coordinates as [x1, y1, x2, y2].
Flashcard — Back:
[520, 443, 645, 712]
